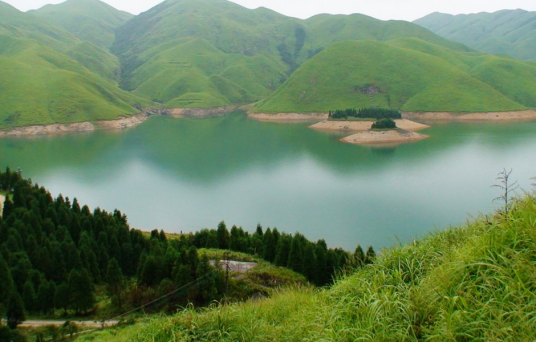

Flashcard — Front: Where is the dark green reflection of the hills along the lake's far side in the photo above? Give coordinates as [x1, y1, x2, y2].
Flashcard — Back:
[0, 114, 536, 182]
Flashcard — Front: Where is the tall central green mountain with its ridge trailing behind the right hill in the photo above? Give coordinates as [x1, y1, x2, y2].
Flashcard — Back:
[112, 0, 467, 107]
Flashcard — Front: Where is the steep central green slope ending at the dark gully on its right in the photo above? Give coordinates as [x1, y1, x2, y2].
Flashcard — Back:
[113, 0, 294, 107]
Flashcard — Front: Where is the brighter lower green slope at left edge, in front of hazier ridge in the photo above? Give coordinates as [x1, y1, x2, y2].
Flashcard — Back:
[0, 35, 146, 127]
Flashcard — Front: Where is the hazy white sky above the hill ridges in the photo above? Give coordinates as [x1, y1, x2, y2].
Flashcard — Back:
[4, 0, 536, 21]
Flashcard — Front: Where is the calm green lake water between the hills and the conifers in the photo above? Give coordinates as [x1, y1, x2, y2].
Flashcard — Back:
[0, 115, 536, 250]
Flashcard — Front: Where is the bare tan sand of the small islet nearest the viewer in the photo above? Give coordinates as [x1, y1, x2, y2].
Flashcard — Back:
[341, 129, 429, 145]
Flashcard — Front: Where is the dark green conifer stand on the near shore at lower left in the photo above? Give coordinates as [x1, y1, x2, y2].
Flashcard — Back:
[0, 168, 372, 327]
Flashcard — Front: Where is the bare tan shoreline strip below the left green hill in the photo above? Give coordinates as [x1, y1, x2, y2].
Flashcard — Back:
[0, 114, 147, 137]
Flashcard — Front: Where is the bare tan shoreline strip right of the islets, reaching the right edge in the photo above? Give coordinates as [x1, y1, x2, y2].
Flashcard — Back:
[402, 110, 536, 122]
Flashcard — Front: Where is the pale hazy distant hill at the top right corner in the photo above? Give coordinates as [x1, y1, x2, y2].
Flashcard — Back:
[414, 9, 536, 62]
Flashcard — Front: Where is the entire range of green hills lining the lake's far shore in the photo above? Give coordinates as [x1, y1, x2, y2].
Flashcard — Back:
[0, 0, 536, 126]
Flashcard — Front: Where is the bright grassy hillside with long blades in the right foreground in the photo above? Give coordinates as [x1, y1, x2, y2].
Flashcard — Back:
[79, 192, 536, 342]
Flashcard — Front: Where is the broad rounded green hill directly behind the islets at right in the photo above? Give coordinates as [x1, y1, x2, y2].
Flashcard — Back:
[256, 39, 536, 112]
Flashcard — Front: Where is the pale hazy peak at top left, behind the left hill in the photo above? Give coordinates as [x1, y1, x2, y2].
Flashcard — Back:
[29, 0, 134, 50]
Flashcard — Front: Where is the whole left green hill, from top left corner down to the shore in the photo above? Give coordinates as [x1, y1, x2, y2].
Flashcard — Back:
[0, 2, 149, 127]
